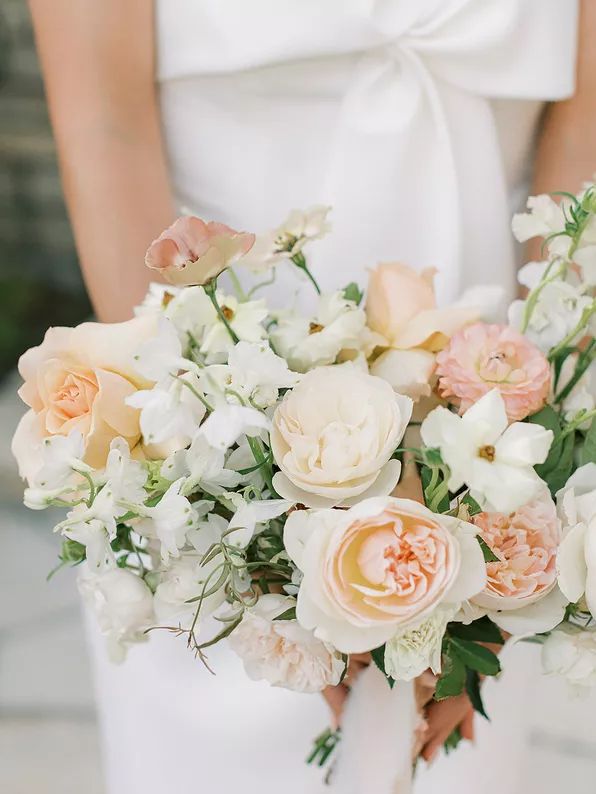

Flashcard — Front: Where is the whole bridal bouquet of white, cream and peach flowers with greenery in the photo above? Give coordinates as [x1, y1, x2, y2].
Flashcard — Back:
[13, 186, 596, 757]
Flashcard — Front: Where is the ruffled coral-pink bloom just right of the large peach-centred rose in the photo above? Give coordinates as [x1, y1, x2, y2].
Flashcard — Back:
[472, 490, 560, 609]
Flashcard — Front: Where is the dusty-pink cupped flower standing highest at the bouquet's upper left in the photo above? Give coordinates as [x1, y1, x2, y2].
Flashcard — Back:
[145, 216, 255, 286]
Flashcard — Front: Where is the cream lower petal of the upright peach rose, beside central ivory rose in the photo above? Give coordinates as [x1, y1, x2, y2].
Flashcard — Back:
[370, 348, 436, 402]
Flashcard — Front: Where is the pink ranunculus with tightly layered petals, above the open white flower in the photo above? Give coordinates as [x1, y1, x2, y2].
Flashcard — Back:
[436, 323, 551, 422]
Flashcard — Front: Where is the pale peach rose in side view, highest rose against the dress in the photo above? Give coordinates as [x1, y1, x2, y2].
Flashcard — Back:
[366, 262, 479, 400]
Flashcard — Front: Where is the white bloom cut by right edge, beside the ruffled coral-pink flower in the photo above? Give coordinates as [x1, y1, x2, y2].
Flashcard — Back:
[557, 463, 596, 616]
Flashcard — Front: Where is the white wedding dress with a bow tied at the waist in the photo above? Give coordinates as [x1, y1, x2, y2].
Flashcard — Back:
[90, 0, 577, 794]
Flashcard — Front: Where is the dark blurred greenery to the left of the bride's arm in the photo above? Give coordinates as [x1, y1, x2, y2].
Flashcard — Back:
[0, 0, 91, 378]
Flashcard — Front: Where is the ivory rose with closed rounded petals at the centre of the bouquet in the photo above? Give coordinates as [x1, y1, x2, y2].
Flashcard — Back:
[271, 364, 412, 507]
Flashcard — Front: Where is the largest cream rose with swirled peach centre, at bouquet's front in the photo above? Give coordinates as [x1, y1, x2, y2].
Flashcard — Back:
[284, 497, 486, 653]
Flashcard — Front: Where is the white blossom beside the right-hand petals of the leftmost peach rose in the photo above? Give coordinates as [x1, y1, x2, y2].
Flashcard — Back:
[125, 372, 206, 446]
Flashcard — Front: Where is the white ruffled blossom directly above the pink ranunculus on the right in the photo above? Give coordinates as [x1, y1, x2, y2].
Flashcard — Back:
[509, 262, 594, 353]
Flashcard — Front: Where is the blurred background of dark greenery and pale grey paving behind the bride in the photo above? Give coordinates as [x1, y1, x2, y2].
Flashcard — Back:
[0, 0, 596, 794]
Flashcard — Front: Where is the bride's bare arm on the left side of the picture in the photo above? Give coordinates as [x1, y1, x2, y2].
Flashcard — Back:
[29, 0, 174, 321]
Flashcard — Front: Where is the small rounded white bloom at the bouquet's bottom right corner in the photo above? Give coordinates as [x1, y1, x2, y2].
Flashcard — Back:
[542, 626, 596, 695]
